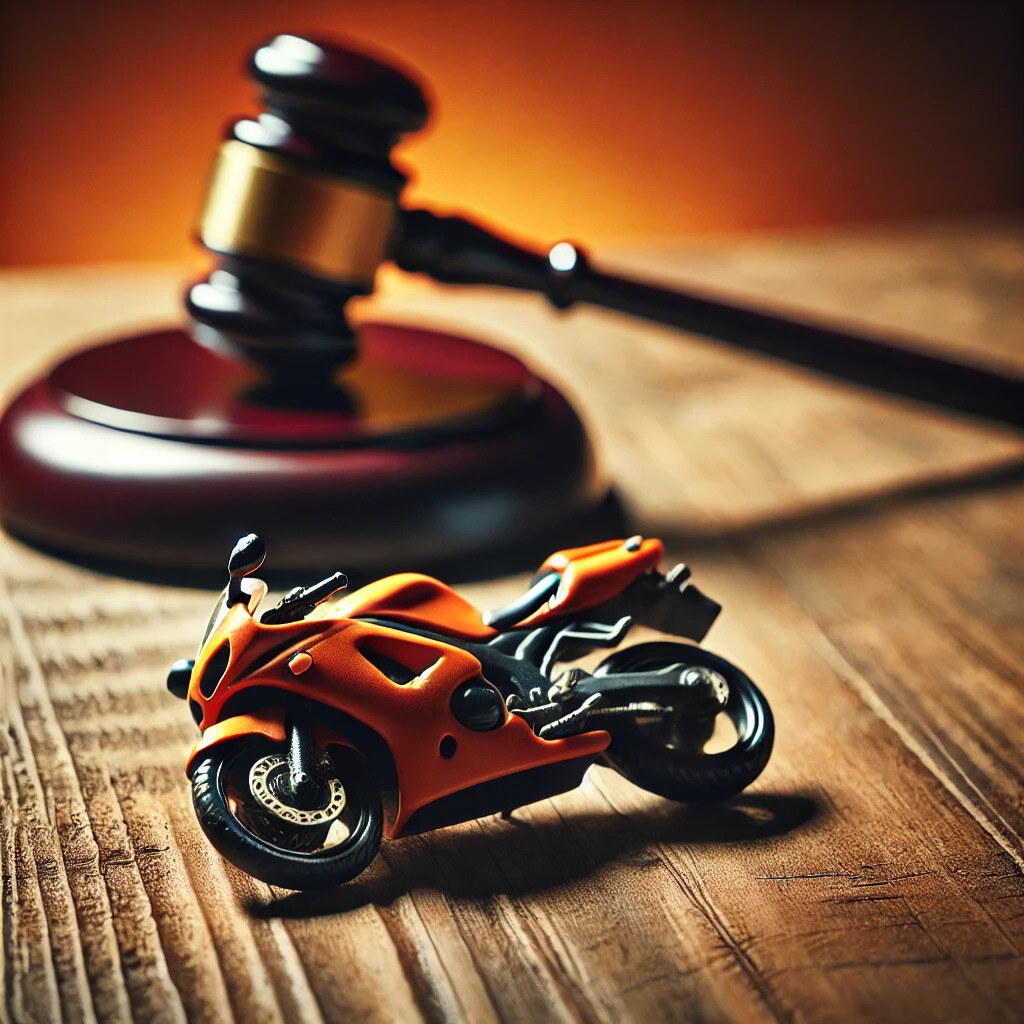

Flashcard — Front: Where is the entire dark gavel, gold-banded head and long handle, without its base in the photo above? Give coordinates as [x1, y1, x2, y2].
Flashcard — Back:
[188, 35, 1024, 427]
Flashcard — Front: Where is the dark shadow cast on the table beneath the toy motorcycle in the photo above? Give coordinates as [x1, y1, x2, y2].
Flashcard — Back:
[244, 794, 822, 919]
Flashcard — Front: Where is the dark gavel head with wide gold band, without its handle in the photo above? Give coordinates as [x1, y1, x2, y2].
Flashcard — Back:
[187, 35, 428, 391]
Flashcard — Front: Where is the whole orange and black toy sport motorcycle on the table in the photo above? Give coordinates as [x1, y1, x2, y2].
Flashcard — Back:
[167, 535, 774, 889]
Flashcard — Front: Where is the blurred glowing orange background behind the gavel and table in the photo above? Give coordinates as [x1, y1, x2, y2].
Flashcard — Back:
[0, 0, 1024, 264]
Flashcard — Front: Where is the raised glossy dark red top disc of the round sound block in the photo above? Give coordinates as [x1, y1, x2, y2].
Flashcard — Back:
[46, 323, 540, 449]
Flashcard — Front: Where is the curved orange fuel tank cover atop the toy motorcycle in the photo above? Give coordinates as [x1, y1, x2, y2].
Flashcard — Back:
[319, 572, 497, 640]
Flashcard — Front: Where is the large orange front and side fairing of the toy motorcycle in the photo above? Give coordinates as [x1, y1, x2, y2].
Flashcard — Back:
[188, 602, 610, 838]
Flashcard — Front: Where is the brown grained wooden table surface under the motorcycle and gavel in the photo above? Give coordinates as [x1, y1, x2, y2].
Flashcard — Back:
[0, 225, 1024, 1024]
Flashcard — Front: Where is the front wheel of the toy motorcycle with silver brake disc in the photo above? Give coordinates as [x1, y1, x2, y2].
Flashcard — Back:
[191, 739, 383, 890]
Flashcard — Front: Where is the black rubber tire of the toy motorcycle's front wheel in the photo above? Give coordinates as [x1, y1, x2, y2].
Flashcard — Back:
[191, 743, 384, 890]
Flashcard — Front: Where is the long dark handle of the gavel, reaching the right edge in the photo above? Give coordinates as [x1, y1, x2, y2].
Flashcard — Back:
[393, 210, 1024, 428]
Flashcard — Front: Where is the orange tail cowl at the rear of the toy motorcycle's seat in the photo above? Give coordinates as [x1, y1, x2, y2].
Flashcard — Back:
[521, 537, 665, 626]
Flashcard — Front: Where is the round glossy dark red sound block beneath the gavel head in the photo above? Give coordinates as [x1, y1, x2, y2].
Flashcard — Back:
[0, 324, 616, 582]
